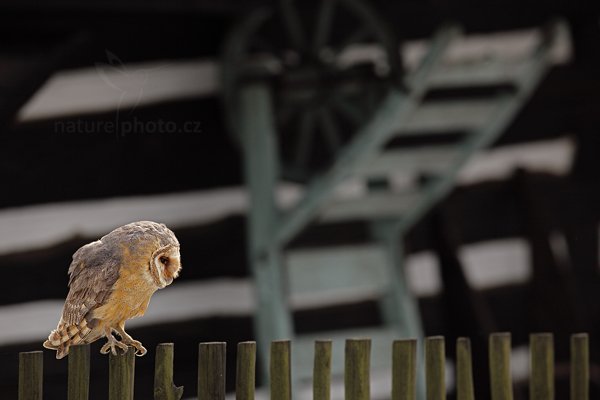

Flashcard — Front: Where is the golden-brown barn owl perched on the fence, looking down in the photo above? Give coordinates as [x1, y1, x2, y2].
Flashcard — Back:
[44, 221, 181, 358]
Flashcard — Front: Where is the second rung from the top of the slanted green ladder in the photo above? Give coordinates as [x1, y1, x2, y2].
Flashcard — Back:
[397, 97, 506, 134]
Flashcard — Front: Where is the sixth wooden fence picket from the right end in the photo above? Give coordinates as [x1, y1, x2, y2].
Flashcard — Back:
[392, 339, 417, 400]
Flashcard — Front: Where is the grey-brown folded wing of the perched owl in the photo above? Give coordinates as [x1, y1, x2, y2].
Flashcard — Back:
[62, 240, 121, 325]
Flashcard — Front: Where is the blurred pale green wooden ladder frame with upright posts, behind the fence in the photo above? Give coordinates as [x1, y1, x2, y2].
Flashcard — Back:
[232, 14, 567, 398]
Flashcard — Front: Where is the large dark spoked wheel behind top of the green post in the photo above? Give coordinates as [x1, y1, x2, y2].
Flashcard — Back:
[221, 0, 402, 182]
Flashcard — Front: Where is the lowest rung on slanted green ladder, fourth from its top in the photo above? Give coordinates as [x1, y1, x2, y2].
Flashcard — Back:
[320, 192, 419, 222]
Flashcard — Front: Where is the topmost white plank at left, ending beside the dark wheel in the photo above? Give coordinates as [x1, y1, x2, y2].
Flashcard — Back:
[18, 55, 219, 122]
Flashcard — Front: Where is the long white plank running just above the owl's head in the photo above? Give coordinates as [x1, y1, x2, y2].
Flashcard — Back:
[0, 184, 301, 254]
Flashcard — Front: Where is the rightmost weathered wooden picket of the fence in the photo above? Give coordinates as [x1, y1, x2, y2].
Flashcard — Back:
[571, 333, 590, 400]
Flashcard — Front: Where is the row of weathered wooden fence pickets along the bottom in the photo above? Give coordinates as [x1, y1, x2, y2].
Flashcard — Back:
[19, 333, 589, 400]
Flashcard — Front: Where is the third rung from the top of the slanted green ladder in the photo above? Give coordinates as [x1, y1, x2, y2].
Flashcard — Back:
[357, 145, 459, 176]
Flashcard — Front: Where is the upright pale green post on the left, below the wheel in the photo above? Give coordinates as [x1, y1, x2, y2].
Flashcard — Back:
[240, 83, 293, 377]
